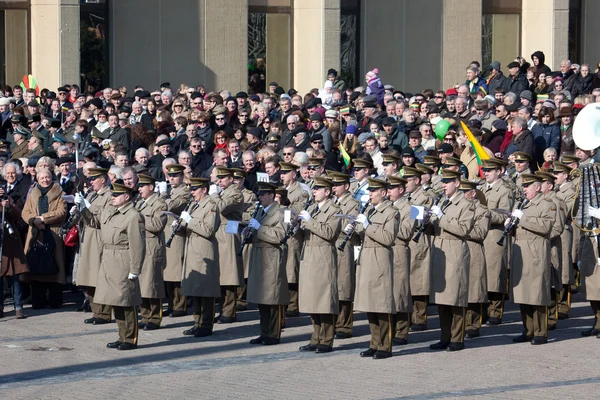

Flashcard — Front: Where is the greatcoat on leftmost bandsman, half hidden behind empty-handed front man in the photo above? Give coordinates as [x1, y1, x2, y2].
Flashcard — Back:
[76, 186, 112, 287]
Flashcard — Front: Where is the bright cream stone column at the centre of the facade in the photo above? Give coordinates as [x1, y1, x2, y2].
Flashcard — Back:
[293, 0, 340, 94]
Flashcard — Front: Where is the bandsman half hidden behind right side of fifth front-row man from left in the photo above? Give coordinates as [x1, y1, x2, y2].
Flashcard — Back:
[388, 176, 415, 346]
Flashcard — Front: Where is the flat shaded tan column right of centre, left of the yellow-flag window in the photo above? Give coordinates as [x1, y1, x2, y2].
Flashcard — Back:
[442, 0, 482, 90]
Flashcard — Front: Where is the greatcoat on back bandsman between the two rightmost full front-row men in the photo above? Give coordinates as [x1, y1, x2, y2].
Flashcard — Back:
[481, 180, 513, 293]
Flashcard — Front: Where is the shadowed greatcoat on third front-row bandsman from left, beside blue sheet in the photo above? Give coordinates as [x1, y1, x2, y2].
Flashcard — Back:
[247, 203, 290, 305]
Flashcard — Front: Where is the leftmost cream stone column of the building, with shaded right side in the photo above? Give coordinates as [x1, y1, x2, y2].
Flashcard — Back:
[31, 0, 80, 90]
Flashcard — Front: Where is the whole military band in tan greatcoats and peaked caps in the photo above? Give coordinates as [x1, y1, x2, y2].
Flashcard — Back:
[71, 148, 600, 359]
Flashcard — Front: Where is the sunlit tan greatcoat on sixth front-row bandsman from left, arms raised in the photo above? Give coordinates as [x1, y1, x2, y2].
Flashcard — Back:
[429, 192, 475, 307]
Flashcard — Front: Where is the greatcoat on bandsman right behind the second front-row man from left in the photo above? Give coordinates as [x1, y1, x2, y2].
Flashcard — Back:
[212, 184, 246, 286]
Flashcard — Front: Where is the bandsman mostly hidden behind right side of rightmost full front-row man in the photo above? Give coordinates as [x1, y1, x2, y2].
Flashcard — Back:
[535, 171, 568, 331]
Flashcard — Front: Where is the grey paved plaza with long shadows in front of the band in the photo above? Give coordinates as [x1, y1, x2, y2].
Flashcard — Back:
[0, 296, 600, 400]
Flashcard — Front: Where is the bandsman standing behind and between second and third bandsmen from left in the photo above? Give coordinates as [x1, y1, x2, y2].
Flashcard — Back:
[162, 164, 191, 318]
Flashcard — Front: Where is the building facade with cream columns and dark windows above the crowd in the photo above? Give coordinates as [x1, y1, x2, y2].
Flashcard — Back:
[0, 0, 600, 93]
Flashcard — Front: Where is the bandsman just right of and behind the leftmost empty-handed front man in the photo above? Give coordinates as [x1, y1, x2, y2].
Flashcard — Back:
[135, 174, 167, 331]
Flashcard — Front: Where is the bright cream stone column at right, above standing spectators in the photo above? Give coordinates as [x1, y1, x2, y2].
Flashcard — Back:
[521, 0, 575, 71]
